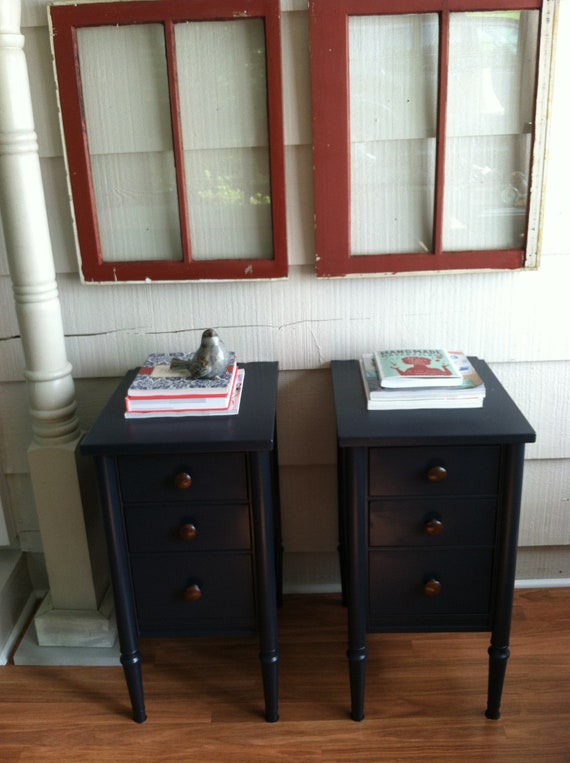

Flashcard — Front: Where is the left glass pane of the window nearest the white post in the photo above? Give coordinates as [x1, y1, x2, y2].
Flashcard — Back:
[77, 24, 182, 262]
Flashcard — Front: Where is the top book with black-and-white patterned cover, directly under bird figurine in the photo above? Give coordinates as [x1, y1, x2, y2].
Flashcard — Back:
[127, 352, 237, 399]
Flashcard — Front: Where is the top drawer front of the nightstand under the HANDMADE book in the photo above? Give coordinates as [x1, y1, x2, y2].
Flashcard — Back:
[369, 445, 500, 497]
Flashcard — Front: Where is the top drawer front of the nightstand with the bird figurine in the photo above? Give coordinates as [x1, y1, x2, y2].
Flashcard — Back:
[118, 453, 247, 502]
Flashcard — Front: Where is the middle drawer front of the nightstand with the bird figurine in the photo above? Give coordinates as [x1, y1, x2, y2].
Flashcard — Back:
[125, 503, 251, 552]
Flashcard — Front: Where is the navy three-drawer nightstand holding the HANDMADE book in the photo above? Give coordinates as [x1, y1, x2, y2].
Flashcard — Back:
[331, 358, 536, 721]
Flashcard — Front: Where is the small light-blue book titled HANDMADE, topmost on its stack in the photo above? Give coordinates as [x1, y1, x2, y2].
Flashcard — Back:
[374, 349, 463, 389]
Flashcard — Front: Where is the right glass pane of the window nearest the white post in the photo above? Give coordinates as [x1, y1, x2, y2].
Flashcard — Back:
[175, 19, 273, 260]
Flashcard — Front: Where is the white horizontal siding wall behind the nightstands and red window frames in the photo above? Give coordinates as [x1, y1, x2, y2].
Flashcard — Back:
[0, 0, 570, 590]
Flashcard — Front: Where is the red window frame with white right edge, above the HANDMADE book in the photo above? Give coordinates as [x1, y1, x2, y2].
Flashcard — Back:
[309, 0, 555, 277]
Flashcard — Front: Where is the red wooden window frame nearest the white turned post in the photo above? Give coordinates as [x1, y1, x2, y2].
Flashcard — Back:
[49, 0, 287, 282]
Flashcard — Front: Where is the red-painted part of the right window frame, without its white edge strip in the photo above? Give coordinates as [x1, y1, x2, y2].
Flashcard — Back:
[309, 0, 542, 277]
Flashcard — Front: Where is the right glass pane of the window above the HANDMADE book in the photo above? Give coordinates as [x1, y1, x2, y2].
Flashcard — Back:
[443, 11, 539, 251]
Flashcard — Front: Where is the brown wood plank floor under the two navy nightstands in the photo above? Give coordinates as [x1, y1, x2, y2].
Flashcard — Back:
[0, 589, 570, 763]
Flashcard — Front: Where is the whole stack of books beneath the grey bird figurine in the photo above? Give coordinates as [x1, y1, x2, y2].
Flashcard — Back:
[125, 352, 245, 419]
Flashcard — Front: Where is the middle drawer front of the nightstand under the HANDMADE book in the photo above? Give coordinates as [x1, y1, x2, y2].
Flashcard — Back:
[369, 497, 497, 547]
